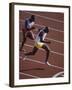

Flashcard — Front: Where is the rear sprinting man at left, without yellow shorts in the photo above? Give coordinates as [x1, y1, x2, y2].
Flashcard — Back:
[20, 15, 35, 51]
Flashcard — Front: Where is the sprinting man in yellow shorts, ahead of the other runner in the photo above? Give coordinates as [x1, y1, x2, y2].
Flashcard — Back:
[25, 27, 50, 63]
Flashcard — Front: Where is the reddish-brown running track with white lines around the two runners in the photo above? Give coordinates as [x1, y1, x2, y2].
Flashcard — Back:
[19, 11, 64, 79]
